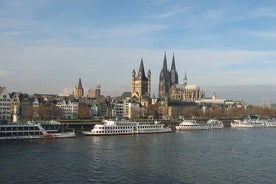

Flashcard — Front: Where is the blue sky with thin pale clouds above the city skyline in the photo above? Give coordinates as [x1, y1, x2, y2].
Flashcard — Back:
[0, 0, 276, 104]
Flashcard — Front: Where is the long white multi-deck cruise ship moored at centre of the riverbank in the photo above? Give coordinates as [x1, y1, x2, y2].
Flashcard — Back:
[82, 120, 172, 135]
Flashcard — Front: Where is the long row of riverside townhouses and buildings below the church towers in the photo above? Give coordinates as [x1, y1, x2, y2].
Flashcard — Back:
[0, 87, 252, 122]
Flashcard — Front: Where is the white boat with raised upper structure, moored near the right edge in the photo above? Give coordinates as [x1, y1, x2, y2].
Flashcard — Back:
[231, 115, 268, 128]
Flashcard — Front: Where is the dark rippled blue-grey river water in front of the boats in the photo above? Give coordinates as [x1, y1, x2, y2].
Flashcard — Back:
[0, 128, 276, 184]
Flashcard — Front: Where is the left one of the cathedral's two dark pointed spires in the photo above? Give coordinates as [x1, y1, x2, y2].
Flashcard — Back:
[159, 52, 171, 100]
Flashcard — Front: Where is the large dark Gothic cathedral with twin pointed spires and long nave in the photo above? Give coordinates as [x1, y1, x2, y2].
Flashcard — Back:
[159, 53, 205, 102]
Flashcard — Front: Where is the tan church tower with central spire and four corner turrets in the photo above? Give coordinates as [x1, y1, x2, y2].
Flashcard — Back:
[131, 58, 151, 99]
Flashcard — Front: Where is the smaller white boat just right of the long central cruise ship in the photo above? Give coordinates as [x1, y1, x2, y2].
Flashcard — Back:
[175, 119, 224, 131]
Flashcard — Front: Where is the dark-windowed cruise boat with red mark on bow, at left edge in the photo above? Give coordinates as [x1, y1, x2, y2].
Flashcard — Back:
[0, 121, 76, 140]
